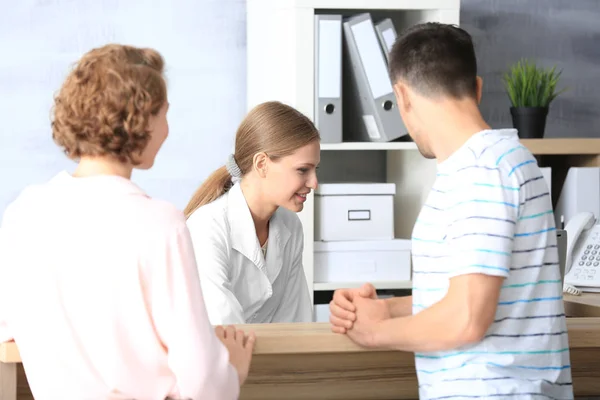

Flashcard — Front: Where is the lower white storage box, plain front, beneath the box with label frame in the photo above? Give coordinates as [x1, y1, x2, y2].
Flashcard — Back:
[314, 239, 411, 283]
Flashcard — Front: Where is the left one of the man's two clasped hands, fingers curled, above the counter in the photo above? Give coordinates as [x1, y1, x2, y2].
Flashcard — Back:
[329, 283, 377, 333]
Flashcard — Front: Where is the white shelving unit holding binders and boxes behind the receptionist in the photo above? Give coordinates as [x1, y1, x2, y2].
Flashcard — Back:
[247, 0, 460, 304]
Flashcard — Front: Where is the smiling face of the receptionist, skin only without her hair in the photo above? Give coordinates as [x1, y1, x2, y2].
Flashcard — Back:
[263, 140, 321, 212]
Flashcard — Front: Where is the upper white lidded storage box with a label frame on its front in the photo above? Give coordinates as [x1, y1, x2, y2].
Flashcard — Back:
[315, 183, 396, 241]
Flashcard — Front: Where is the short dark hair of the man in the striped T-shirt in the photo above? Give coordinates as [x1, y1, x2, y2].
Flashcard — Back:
[389, 22, 477, 99]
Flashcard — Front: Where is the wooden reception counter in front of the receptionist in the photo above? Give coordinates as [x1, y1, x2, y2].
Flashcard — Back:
[0, 294, 600, 400]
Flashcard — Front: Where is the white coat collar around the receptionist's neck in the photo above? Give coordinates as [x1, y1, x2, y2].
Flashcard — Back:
[227, 184, 291, 283]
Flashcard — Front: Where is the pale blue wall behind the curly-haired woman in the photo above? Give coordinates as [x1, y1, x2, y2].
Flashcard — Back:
[0, 0, 246, 215]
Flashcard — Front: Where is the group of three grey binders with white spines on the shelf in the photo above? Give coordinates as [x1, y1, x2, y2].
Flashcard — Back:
[314, 13, 408, 143]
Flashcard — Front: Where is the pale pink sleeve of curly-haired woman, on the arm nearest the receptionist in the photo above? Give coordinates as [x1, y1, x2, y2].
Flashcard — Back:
[146, 223, 240, 400]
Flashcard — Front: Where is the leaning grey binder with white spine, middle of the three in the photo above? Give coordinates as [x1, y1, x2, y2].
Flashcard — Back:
[343, 13, 408, 142]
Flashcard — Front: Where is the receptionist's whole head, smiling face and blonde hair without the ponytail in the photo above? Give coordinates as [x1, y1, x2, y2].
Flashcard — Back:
[233, 101, 321, 218]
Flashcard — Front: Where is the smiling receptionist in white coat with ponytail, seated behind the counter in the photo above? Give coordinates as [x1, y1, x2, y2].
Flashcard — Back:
[185, 102, 320, 325]
